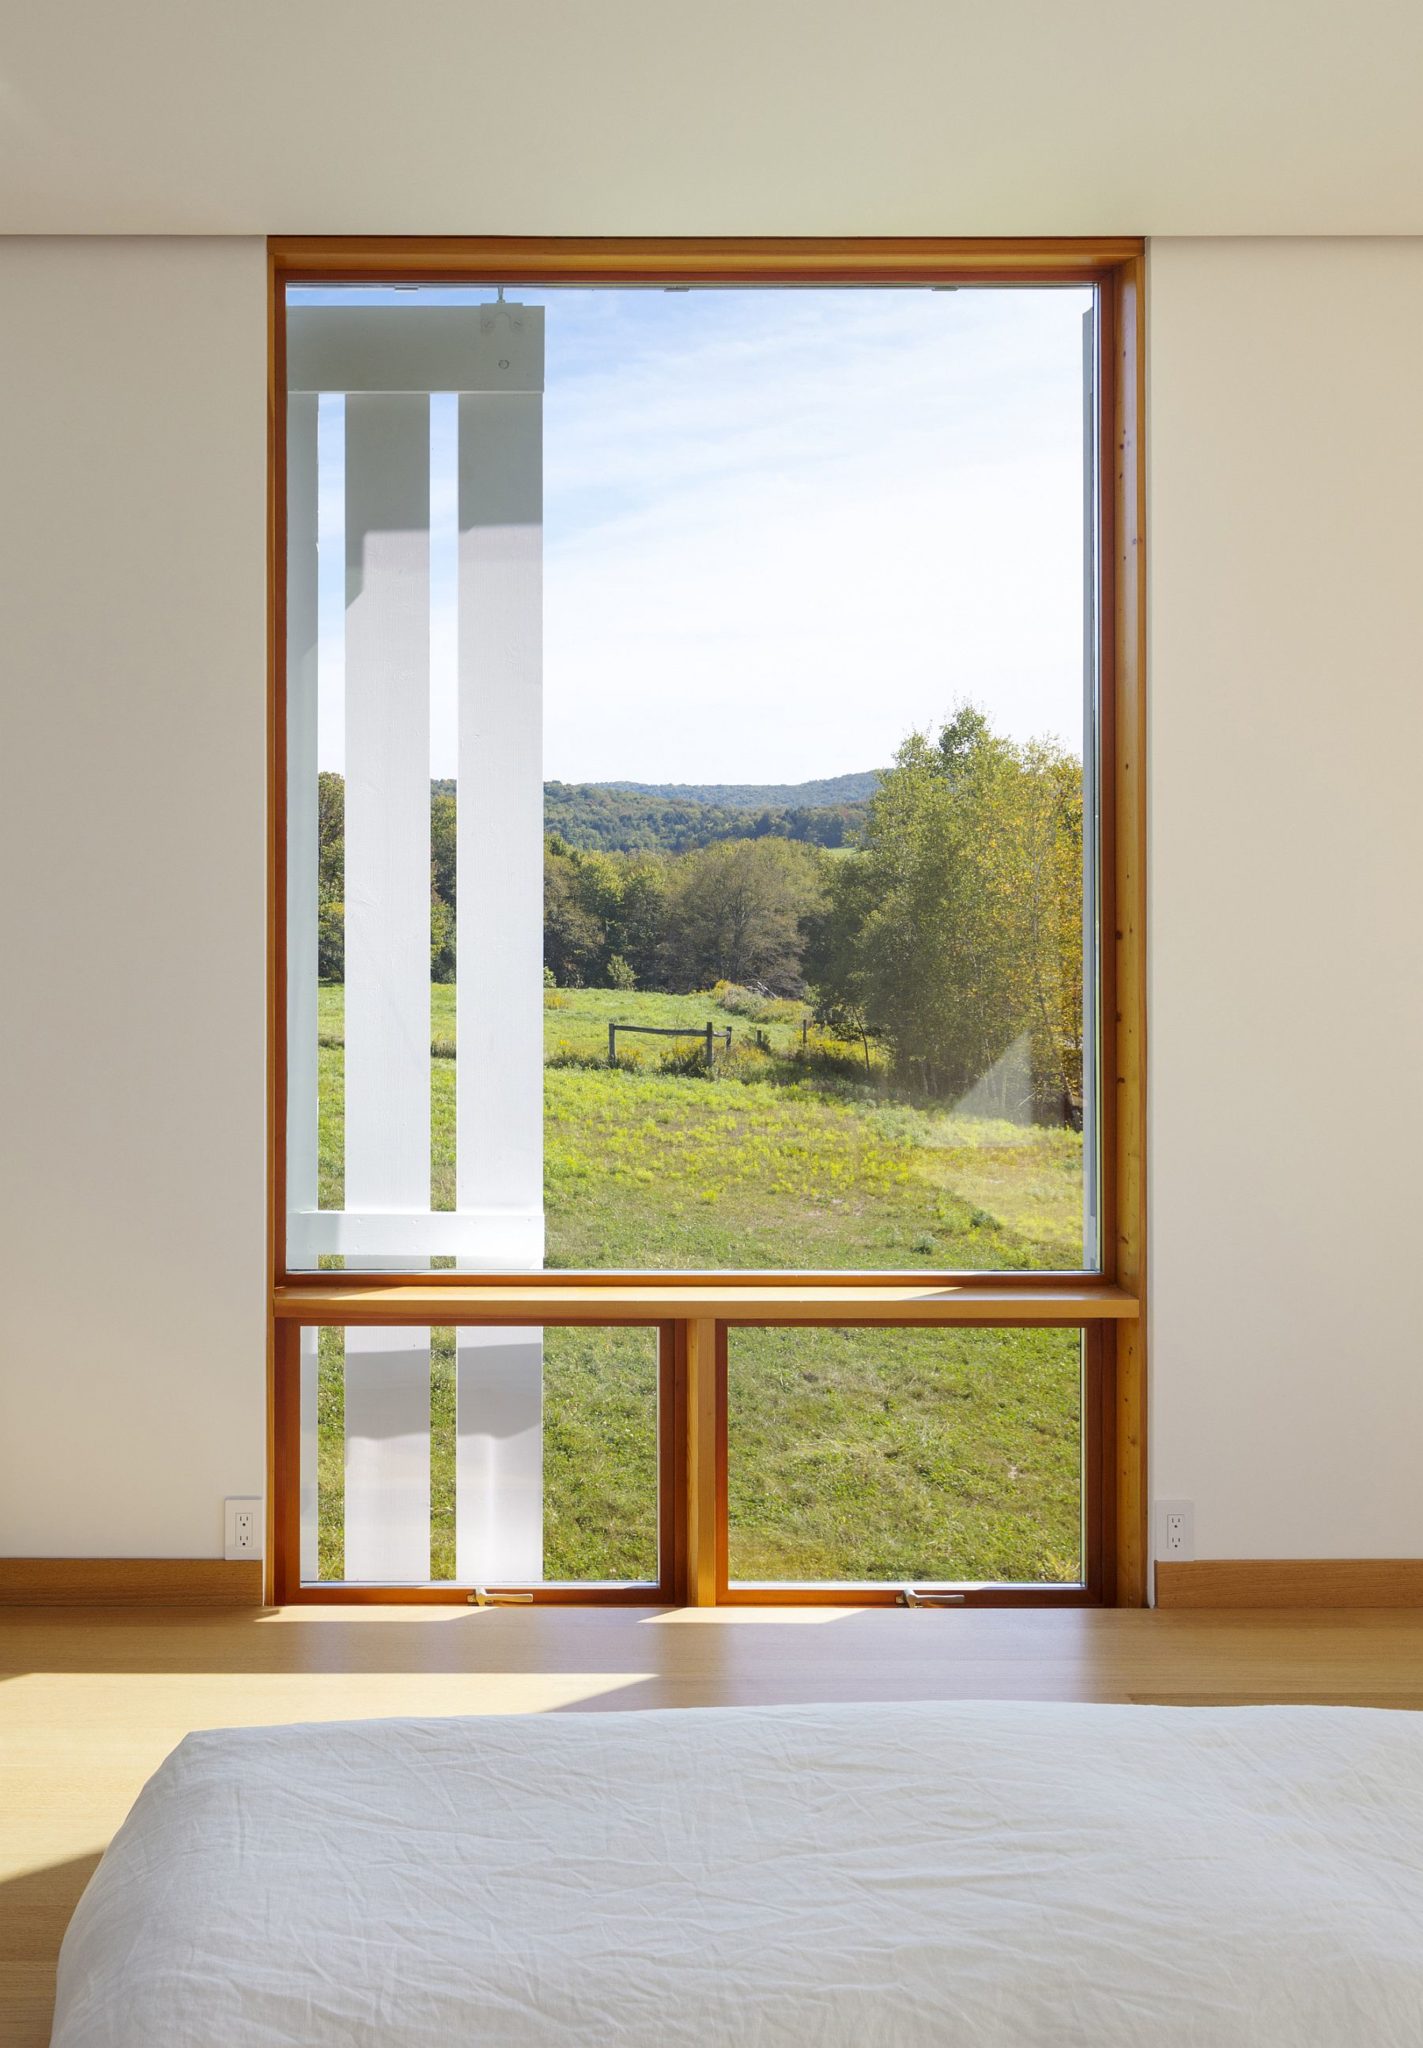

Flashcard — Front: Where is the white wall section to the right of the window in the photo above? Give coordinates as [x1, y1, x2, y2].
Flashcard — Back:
[1149, 242, 1423, 1556]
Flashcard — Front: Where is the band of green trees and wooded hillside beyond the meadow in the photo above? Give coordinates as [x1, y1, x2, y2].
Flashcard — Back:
[321, 707, 1083, 1120]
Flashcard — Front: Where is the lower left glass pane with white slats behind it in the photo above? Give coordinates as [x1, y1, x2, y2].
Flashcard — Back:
[303, 1327, 659, 1585]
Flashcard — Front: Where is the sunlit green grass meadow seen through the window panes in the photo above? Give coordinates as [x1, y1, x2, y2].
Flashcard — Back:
[319, 985, 1081, 1581]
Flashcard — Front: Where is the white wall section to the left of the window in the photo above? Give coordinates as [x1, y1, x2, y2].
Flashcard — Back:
[0, 240, 266, 1556]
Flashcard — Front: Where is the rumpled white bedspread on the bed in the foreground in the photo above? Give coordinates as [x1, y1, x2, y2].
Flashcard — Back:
[53, 1704, 1423, 2048]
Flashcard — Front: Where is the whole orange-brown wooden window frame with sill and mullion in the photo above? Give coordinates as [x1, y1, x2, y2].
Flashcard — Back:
[266, 238, 1149, 1606]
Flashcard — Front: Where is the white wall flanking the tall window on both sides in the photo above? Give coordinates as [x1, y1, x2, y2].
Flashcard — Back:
[0, 219, 1423, 1556]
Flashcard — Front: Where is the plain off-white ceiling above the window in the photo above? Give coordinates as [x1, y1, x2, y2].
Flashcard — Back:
[0, 0, 1423, 236]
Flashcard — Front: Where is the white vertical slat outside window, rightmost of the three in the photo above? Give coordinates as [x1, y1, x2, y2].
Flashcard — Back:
[455, 305, 543, 1583]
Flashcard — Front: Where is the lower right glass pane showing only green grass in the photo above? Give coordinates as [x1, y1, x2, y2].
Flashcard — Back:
[727, 1329, 1083, 1585]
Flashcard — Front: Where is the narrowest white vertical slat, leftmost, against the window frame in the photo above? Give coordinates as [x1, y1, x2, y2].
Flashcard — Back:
[287, 391, 317, 1579]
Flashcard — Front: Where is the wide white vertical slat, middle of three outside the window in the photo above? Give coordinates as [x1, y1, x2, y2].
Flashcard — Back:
[346, 393, 430, 1581]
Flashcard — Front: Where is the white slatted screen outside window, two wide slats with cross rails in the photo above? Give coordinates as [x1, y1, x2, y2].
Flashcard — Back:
[287, 305, 543, 1583]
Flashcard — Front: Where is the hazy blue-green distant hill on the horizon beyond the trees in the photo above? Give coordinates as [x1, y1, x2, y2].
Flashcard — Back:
[543, 772, 878, 854]
